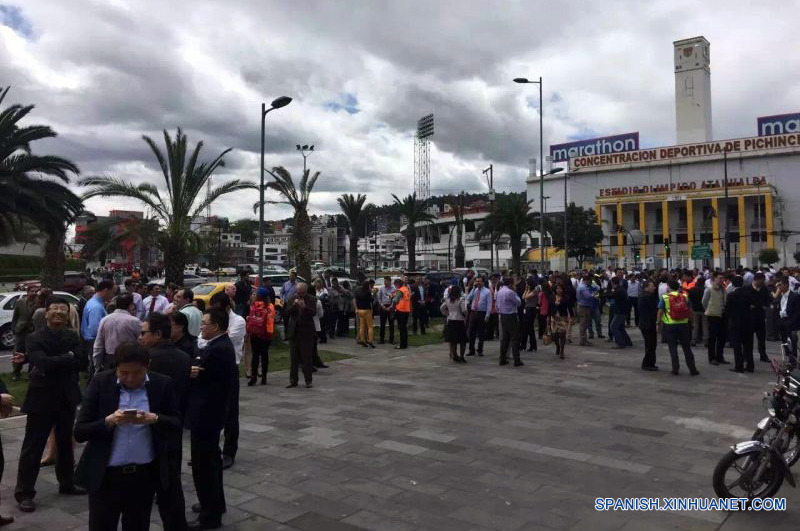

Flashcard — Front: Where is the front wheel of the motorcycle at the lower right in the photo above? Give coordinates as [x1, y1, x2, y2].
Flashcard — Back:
[713, 450, 784, 500]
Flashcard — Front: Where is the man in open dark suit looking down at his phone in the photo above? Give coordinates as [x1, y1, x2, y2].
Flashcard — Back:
[74, 343, 183, 531]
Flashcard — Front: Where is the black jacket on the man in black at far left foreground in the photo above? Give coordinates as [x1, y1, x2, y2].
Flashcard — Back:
[22, 326, 83, 413]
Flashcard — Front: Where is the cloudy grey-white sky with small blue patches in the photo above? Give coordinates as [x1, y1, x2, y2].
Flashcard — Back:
[0, 0, 800, 223]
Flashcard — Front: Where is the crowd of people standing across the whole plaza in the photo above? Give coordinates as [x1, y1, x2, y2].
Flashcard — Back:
[0, 268, 800, 531]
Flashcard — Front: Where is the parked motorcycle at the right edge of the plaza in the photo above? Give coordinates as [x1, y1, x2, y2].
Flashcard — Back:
[713, 343, 800, 500]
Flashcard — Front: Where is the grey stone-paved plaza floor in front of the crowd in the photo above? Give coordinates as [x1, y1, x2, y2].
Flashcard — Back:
[0, 331, 800, 531]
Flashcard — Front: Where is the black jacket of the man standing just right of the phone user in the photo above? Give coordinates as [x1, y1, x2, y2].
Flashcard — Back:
[186, 334, 236, 435]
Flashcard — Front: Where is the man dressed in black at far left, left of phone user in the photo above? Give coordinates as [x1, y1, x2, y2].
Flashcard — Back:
[14, 297, 86, 513]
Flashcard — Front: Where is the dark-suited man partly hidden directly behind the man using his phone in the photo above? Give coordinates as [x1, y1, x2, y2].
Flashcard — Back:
[139, 313, 192, 531]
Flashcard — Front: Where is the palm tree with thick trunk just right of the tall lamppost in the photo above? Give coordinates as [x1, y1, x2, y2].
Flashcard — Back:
[254, 166, 319, 280]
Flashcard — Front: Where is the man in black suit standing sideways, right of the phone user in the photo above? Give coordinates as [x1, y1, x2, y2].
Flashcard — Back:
[186, 307, 236, 529]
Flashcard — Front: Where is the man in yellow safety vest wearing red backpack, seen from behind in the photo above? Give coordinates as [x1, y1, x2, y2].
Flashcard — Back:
[657, 279, 700, 376]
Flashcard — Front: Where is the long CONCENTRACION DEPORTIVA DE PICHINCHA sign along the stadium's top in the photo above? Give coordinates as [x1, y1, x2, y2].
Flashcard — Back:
[569, 133, 800, 171]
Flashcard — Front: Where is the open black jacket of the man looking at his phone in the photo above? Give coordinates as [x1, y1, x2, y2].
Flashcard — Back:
[75, 371, 181, 494]
